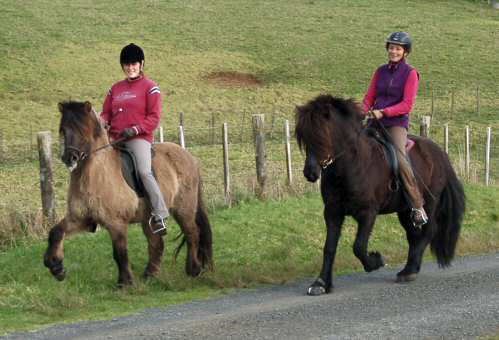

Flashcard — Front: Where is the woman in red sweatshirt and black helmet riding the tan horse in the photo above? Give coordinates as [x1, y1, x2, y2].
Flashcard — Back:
[101, 44, 169, 235]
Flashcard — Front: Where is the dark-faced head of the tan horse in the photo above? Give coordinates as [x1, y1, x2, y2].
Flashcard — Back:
[58, 101, 103, 171]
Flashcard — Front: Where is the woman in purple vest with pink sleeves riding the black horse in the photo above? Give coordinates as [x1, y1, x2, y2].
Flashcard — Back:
[363, 32, 428, 228]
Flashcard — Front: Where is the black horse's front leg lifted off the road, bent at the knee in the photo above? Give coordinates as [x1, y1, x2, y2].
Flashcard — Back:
[353, 210, 385, 272]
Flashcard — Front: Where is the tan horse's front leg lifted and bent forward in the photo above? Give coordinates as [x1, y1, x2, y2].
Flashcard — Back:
[43, 216, 96, 281]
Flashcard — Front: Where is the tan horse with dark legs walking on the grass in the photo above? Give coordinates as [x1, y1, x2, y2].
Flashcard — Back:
[44, 102, 212, 285]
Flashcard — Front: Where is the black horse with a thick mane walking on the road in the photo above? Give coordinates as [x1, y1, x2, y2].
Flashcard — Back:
[296, 95, 465, 295]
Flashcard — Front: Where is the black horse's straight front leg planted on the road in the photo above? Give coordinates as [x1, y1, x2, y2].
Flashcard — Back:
[307, 210, 345, 295]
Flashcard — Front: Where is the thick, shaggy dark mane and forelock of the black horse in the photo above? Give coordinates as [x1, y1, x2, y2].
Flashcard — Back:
[295, 94, 362, 152]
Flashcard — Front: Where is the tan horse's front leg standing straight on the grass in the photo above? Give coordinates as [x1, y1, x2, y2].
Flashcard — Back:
[107, 224, 133, 287]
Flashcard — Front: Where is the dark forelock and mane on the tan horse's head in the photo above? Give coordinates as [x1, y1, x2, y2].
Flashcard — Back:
[59, 101, 102, 138]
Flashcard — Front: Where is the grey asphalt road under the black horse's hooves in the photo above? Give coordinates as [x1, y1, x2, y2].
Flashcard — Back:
[5, 253, 499, 339]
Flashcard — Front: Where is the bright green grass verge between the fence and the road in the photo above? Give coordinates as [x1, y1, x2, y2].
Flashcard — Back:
[0, 186, 499, 334]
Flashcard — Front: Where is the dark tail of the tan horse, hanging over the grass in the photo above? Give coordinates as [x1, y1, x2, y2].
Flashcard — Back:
[196, 179, 213, 269]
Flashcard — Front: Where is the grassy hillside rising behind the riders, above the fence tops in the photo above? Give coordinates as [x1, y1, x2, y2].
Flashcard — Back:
[0, 0, 499, 140]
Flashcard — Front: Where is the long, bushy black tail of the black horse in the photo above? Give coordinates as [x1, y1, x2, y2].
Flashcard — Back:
[430, 162, 465, 267]
